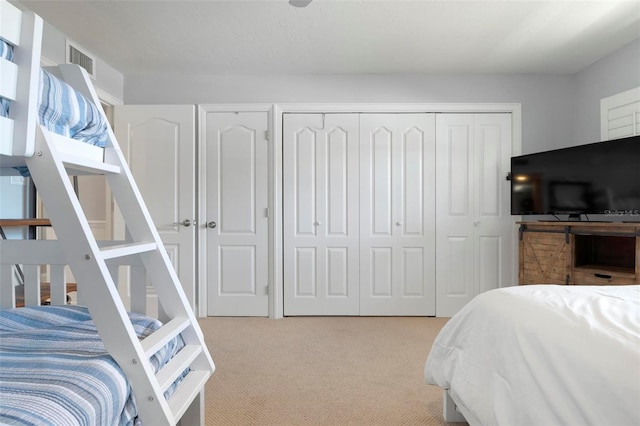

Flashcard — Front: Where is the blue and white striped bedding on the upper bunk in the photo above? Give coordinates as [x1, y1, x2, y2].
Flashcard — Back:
[0, 40, 109, 174]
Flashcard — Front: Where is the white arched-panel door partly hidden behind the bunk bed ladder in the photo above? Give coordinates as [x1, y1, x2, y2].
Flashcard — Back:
[114, 105, 196, 313]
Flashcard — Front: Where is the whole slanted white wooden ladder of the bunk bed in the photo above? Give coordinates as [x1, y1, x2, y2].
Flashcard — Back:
[26, 65, 215, 426]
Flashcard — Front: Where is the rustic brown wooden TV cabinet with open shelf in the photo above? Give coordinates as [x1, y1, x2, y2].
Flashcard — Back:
[518, 222, 640, 285]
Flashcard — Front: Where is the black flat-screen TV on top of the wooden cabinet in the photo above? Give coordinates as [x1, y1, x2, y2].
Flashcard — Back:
[511, 136, 640, 216]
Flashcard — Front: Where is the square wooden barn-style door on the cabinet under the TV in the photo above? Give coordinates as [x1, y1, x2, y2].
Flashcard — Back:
[519, 231, 571, 284]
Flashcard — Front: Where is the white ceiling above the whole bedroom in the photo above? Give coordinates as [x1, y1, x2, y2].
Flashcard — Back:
[13, 0, 640, 75]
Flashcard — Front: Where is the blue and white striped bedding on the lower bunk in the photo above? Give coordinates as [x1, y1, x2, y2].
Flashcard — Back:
[0, 305, 184, 426]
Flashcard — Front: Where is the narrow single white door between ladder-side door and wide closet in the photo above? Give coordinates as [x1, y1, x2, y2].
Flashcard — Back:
[200, 112, 269, 316]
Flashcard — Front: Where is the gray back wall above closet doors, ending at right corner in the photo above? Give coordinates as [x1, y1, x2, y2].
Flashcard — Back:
[125, 74, 575, 153]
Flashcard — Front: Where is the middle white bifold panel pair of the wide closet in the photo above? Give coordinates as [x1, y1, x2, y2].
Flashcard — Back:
[360, 114, 436, 316]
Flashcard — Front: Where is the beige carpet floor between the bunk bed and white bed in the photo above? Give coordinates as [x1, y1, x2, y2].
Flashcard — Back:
[200, 317, 468, 426]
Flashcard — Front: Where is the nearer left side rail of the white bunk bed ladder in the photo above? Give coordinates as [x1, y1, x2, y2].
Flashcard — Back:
[26, 125, 174, 425]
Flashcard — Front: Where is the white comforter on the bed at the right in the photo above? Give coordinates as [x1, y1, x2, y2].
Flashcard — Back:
[425, 285, 640, 426]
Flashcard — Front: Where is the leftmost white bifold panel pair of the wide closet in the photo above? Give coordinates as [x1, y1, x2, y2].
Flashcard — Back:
[283, 114, 359, 315]
